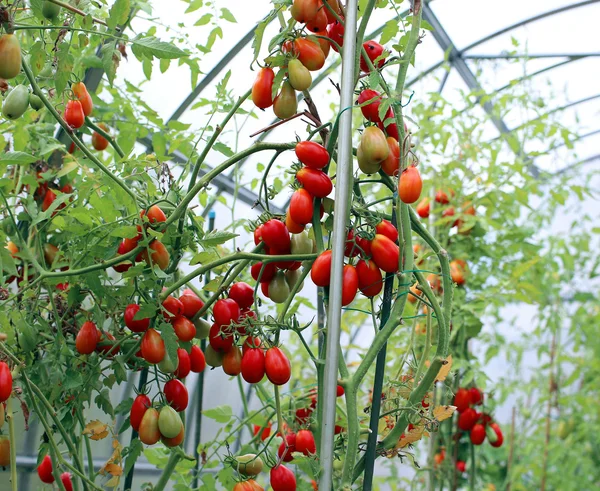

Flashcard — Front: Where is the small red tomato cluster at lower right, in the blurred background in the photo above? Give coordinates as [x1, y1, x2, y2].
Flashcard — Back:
[454, 387, 504, 447]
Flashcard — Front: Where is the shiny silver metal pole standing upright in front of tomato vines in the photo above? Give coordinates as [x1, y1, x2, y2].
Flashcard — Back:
[319, 0, 358, 491]
